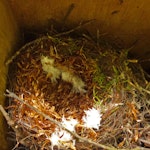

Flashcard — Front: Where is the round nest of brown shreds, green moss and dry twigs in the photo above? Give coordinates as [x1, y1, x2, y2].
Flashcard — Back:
[6, 36, 150, 150]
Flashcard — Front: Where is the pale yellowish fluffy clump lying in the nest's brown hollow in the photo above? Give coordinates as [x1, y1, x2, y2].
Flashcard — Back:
[41, 56, 86, 93]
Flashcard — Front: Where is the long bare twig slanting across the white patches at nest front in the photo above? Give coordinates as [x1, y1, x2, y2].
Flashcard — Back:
[5, 90, 117, 150]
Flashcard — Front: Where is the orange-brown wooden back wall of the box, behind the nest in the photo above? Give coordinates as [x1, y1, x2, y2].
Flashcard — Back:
[11, 0, 150, 68]
